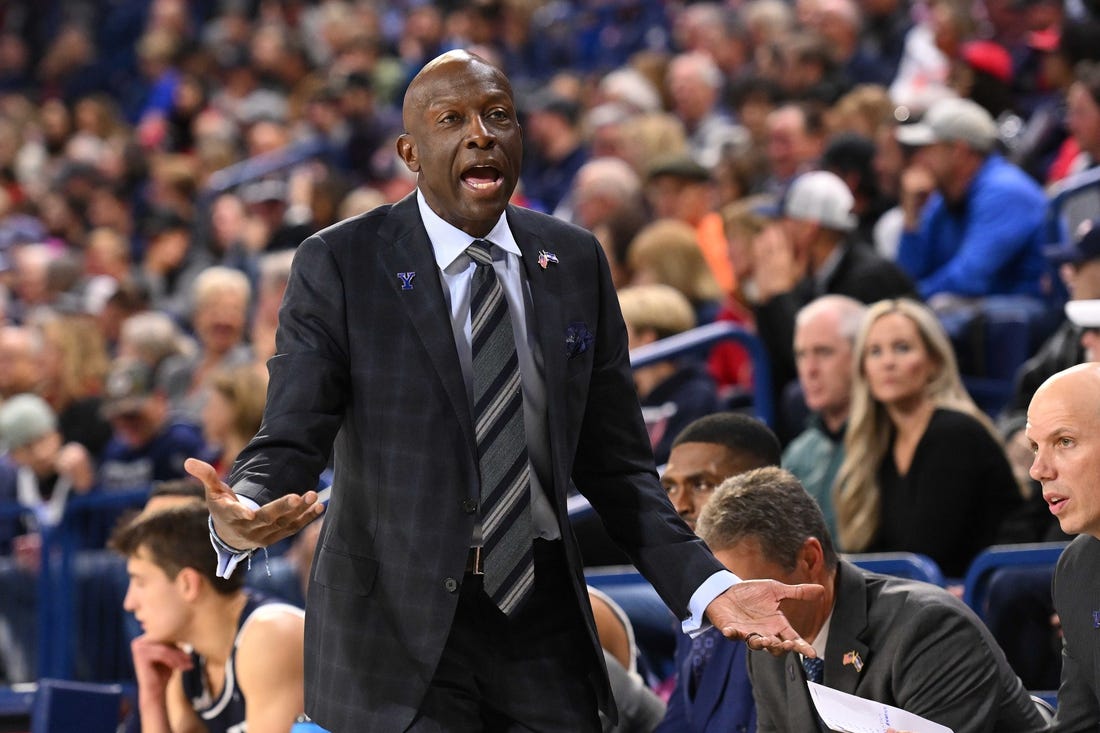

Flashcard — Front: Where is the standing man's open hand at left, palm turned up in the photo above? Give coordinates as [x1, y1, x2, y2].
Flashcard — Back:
[184, 458, 325, 550]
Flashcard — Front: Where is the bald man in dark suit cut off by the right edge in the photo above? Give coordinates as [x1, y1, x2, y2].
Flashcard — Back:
[1026, 362, 1100, 732]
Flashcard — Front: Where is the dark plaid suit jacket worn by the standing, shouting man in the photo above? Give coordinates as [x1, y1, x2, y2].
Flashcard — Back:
[230, 195, 721, 731]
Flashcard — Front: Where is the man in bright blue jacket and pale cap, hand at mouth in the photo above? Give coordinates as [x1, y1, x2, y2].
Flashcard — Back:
[895, 99, 1051, 308]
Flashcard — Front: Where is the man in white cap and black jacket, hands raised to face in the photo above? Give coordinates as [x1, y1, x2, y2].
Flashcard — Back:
[752, 171, 916, 437]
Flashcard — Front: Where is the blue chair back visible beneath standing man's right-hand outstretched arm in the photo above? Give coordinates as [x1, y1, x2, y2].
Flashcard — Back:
[584, 566, 680, 681]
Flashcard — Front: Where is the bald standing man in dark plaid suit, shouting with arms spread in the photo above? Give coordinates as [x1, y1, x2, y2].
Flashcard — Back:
[182, 52, 821, 733]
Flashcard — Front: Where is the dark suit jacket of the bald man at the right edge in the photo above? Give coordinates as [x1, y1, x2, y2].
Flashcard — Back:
[1052, 535, 1100, 733]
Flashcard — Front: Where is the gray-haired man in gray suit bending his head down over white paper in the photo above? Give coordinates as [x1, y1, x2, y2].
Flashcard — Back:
[696, 468, 1046, 733]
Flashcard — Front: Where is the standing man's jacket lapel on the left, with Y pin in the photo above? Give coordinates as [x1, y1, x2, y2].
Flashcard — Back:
[378, 194, 477, 456]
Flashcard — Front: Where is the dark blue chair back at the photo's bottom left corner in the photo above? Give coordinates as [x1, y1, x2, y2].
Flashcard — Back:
[31, 678, 122, 733]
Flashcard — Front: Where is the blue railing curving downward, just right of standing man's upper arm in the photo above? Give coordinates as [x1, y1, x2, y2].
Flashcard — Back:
[630, 321, 776, 426]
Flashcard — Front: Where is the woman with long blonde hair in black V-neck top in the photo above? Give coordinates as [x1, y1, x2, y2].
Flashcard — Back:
[834, 299, 1022, 578]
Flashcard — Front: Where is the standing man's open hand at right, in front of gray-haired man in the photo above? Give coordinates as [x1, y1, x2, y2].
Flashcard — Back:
[706, 580, 825, 657]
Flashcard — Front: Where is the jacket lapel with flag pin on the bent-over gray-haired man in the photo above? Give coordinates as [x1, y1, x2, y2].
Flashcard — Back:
[824, 561, 871, 694]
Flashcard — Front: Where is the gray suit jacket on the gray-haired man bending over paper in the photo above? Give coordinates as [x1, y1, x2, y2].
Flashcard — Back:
[748, 561, 1045, 733]
